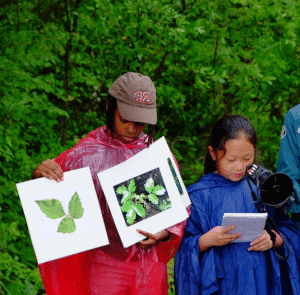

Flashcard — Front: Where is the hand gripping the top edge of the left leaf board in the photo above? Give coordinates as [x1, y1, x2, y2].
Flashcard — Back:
[32, 159, 64, 182]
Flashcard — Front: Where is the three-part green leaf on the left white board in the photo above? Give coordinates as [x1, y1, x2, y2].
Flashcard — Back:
[35, 192, 84, 234]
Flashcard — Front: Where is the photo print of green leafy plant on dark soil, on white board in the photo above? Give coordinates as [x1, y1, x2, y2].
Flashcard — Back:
[114, 168, 172, 226]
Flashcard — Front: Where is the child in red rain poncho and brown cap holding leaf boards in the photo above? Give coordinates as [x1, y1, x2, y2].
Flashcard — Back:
[32, 72, 185, 295]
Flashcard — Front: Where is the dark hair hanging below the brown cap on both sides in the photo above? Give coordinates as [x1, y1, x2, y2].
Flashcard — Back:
[106, 94, 155, 146]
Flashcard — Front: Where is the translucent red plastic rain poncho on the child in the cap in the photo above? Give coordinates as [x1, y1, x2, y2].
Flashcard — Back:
[39, 127, 185, 295]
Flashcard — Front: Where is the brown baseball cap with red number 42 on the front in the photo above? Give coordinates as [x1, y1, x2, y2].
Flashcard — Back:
[108, 72, 157, 125]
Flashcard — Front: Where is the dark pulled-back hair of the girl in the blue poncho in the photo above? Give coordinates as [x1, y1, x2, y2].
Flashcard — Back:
[204, 115, 257, 174]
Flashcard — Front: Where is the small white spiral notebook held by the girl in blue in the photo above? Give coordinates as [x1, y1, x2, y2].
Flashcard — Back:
[222, 213, 268, 243]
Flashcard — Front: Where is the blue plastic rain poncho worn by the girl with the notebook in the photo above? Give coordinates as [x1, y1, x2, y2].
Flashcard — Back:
[175, 173, 300, 295]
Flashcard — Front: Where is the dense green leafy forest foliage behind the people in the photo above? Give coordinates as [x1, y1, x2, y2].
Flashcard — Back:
[0, 0, 300, 295]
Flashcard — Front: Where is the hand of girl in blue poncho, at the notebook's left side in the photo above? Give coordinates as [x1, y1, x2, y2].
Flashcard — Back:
[199, 225, 241, 251]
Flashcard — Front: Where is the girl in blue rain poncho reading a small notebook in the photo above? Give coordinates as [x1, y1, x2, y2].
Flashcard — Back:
[175, 116, 300, 295]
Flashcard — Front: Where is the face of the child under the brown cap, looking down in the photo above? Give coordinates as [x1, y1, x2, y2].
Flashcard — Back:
[114, 108, 146, 144]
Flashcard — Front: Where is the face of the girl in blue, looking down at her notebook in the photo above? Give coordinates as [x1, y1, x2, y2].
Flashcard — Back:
[208, 135, 255, 181]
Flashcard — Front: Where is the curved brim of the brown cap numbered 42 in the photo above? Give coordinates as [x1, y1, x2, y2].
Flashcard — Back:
[117, 100, 157, 125]
